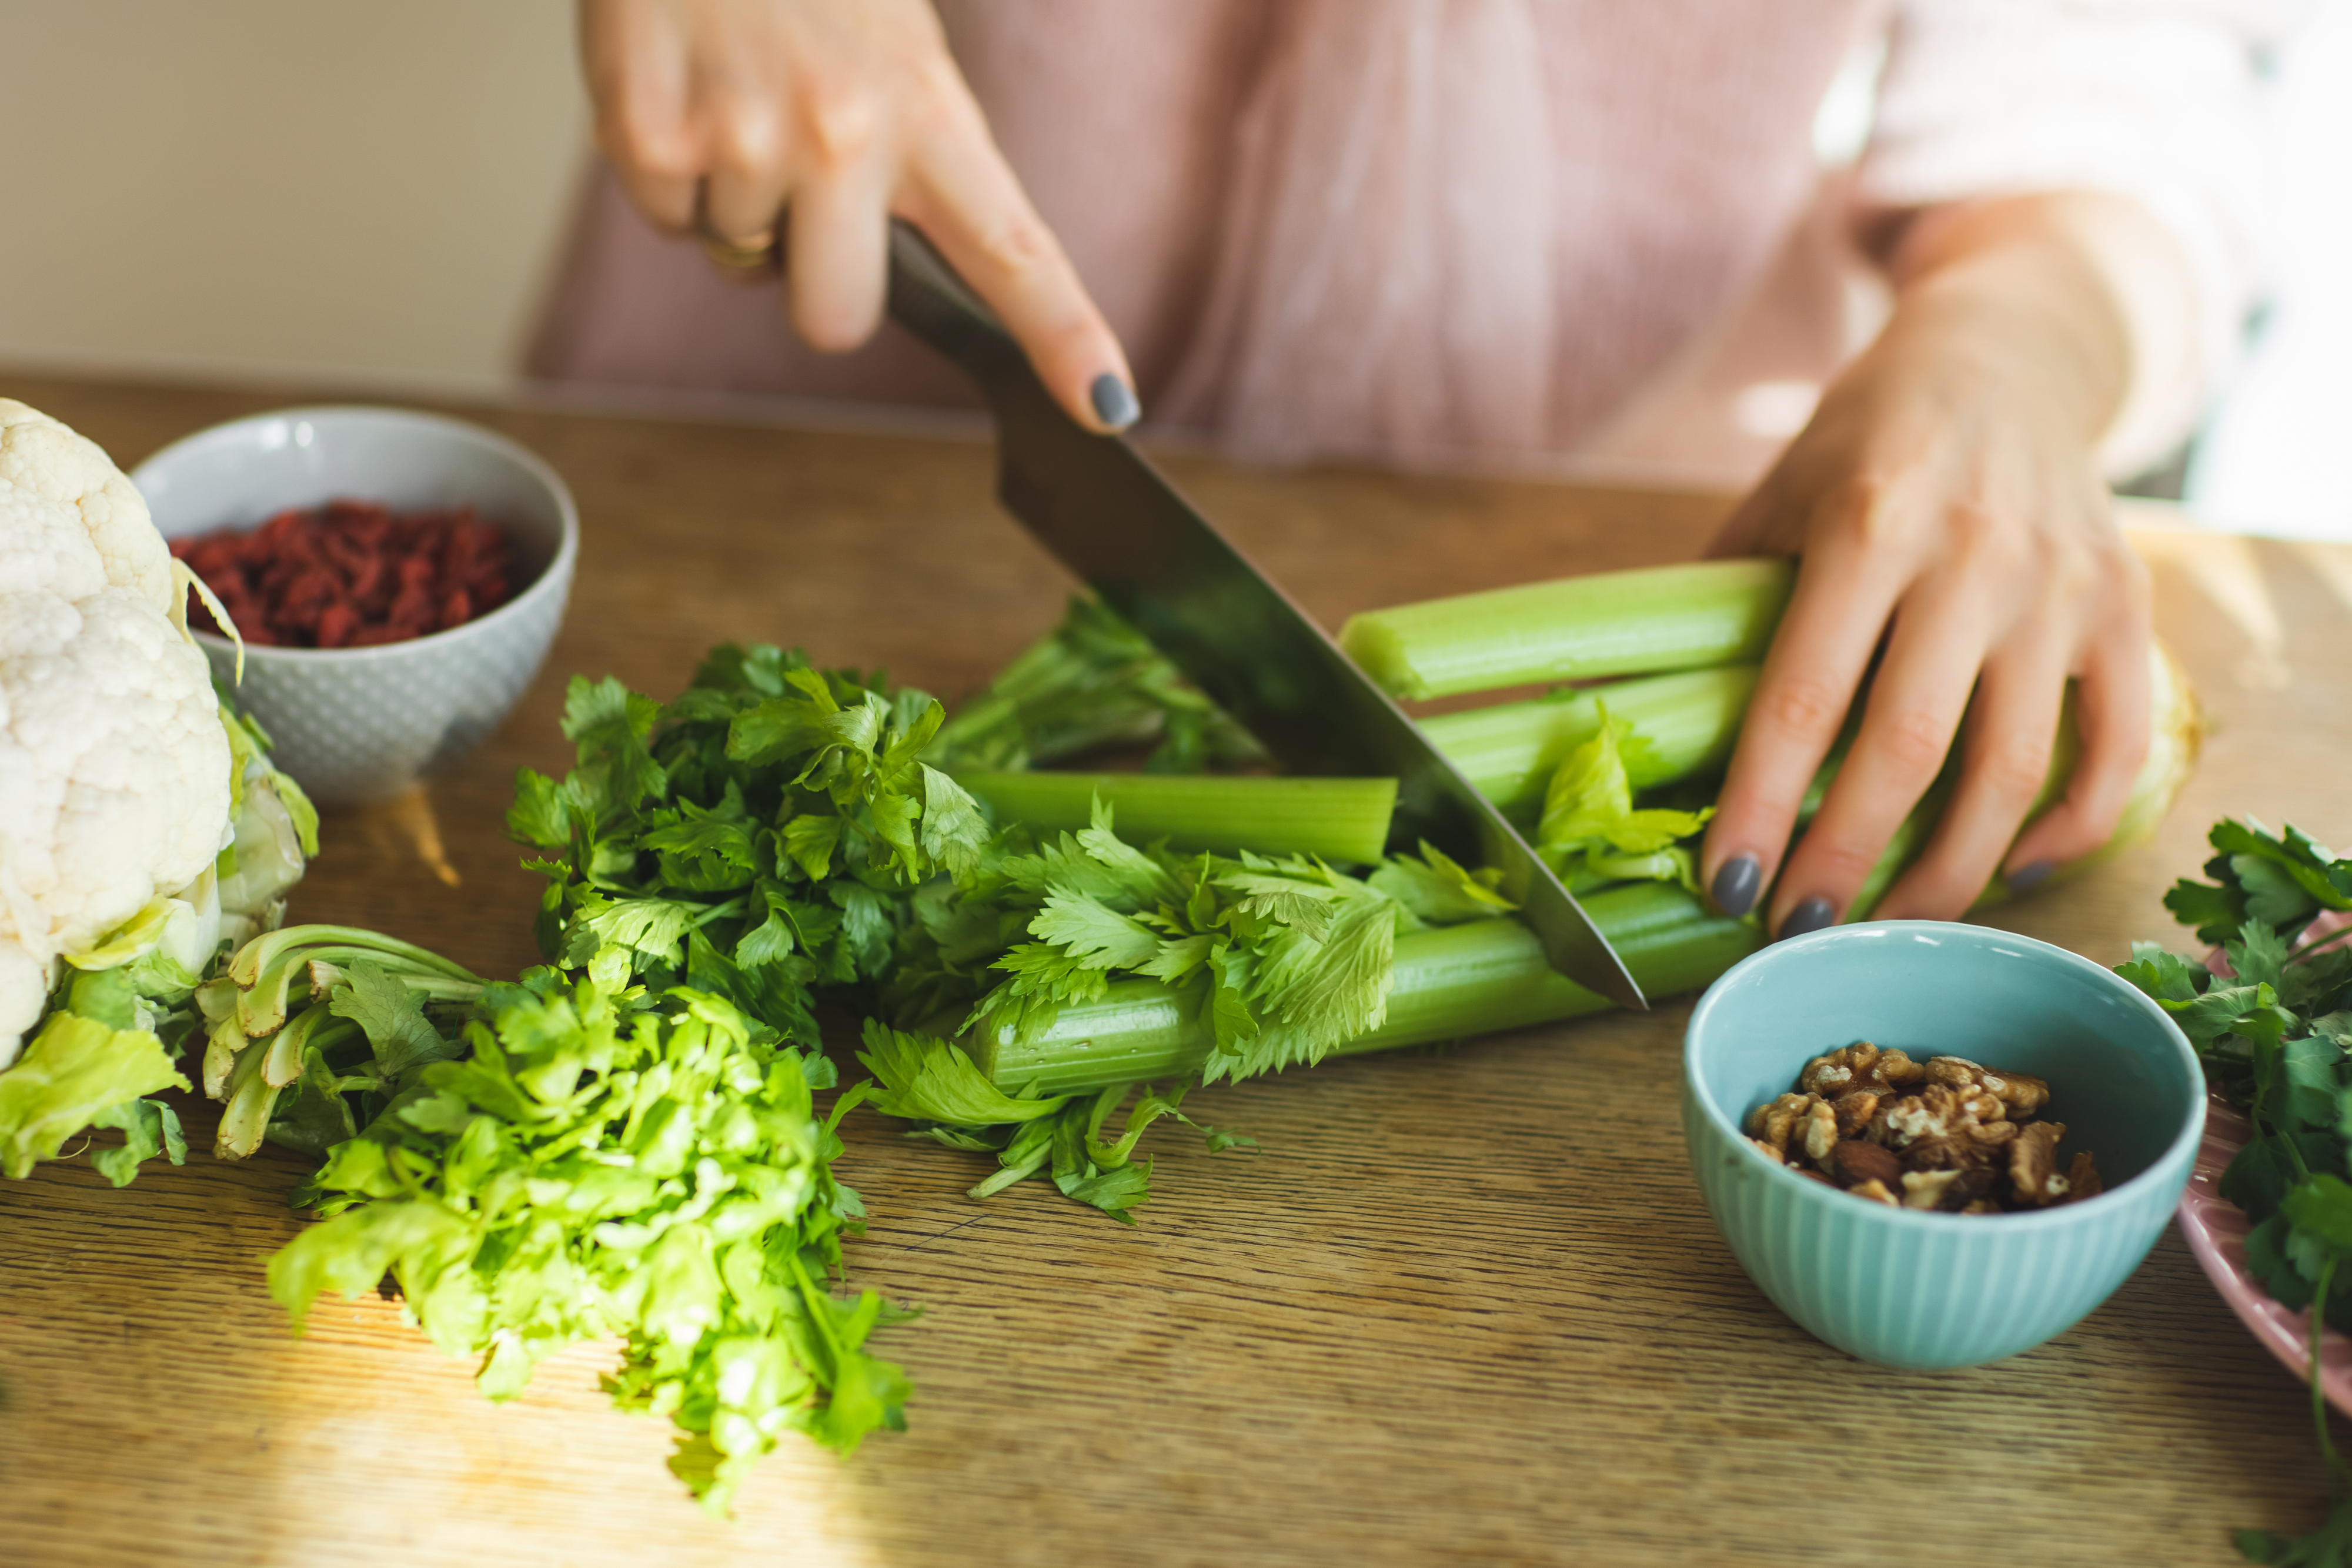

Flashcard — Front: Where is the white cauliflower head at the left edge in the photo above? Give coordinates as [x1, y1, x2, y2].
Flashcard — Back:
[0, 400, 230, 1067]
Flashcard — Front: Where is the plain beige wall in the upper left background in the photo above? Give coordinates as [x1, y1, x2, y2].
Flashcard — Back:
[0, 0, 588, 390]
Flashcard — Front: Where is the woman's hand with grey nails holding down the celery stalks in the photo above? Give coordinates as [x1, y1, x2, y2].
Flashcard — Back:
[1700, 198, 2150, 935]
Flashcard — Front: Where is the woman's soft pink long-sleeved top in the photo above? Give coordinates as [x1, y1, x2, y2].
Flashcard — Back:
[529, 0, 2293, 477]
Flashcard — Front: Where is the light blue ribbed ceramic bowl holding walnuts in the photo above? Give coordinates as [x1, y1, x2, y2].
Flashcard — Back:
[1682, 921, 2204, 1368]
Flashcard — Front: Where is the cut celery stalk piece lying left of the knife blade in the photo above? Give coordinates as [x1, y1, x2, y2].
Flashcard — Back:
[955, 771, 1397, 865]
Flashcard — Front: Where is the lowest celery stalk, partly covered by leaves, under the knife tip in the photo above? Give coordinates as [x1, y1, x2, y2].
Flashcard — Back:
[971, 881, 1764, 1095]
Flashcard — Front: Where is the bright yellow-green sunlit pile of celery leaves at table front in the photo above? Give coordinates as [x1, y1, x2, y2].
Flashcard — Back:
[268, 968, 903, 1512]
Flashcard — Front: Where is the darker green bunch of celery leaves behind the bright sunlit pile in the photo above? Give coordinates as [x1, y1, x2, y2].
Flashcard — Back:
[508, 644, 990, 1048]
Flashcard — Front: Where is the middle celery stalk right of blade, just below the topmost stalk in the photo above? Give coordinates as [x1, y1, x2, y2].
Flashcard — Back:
[1421, 666, 1757, 813]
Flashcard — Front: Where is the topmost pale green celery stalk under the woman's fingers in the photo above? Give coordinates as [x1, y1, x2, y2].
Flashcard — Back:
[1338, 560, 1797, 698]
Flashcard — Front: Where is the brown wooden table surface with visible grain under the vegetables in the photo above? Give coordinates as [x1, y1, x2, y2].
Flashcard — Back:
[0, 379, 2352, 1568]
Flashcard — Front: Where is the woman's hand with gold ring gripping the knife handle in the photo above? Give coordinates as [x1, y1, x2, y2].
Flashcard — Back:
[581, 0, 1136, 430]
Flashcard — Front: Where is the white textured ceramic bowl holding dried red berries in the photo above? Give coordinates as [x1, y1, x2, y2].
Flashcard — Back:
[132, 407, 579, 801]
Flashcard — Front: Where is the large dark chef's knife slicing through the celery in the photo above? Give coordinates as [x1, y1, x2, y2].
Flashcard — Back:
[889, 223, 1649, 1008]
